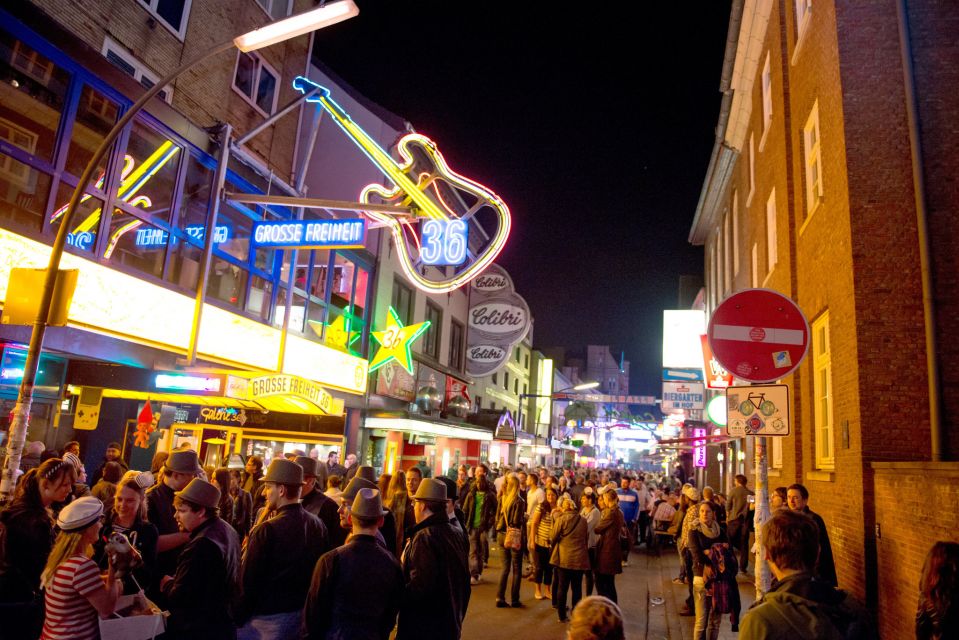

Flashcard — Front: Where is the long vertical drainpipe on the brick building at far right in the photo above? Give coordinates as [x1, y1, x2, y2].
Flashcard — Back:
[896, 0, 943, 462]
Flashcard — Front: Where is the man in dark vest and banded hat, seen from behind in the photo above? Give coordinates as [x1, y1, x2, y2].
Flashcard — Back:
[303, 488, 403, 640]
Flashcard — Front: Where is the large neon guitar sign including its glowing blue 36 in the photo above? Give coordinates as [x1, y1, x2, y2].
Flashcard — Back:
[293, 76, 510, 293]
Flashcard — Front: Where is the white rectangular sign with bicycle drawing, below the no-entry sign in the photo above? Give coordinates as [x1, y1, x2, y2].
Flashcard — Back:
[726, 384, 790, 438]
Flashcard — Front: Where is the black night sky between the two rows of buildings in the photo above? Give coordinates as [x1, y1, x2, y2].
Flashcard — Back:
[315, 0, 730, 396]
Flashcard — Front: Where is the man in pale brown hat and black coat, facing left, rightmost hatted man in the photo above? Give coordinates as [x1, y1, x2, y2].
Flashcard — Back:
[396, 479, 470, 640]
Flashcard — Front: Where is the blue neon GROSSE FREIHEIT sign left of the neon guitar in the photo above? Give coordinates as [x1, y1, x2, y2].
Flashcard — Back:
[253, 218, 366, 249]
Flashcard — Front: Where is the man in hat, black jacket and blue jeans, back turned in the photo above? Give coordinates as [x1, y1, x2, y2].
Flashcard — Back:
[237, 458, 329, 640]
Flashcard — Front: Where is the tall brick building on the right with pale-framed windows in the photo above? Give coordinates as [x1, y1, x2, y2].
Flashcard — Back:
[690, 0, 959, 637]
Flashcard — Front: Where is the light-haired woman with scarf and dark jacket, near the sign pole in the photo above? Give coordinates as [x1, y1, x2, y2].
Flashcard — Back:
[687, 502, 735, 640]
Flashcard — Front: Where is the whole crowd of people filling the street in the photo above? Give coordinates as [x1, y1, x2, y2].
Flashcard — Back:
[0, 443, 959, 640]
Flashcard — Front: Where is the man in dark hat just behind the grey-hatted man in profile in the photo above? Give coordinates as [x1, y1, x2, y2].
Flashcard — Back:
[146, 449, 200, 576]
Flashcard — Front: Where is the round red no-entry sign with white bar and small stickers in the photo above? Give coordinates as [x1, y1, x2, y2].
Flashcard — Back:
[706, 289, 809, 382]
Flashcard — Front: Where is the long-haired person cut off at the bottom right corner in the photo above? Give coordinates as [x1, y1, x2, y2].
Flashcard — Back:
[916, 541, 959, 640]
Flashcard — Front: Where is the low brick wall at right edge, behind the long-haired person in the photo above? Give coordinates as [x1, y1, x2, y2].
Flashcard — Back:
[870, 462, 959, 639]
